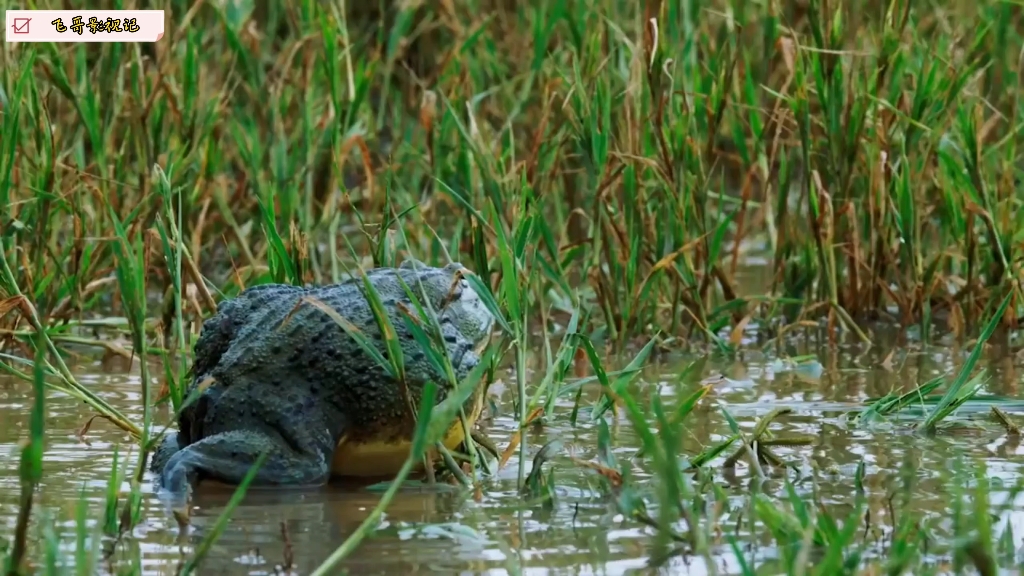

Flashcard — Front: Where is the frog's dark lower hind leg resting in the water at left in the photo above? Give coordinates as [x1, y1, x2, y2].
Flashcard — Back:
[160, 430, 330, 510]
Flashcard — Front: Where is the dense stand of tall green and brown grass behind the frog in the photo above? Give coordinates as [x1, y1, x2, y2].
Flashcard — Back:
[0, 0, 1020, 354]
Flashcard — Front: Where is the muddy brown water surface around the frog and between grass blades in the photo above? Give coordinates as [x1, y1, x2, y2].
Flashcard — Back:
[0, 334, 1024, 574]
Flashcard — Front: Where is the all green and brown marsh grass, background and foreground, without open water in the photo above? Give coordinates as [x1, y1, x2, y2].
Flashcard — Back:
[0, 0, 1024, 574]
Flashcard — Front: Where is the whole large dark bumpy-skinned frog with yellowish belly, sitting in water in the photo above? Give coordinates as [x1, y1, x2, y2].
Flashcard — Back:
[152, 260, 495, 499]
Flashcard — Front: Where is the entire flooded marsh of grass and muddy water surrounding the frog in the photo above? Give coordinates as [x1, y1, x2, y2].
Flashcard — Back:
[0, 0, 1024, 576]
